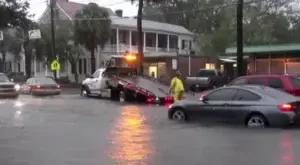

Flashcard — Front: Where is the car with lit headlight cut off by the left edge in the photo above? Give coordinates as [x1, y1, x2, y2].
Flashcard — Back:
[0, 73, 20, 98]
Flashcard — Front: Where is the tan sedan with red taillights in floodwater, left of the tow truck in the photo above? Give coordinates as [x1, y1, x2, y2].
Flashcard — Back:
[21, 77, 61, 95]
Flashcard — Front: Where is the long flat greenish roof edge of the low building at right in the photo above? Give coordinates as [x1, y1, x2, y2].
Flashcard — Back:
[225, 43, 300, 54]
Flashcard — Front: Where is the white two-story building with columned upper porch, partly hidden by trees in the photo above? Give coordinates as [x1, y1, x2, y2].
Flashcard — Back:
[34, 0, 195, 80]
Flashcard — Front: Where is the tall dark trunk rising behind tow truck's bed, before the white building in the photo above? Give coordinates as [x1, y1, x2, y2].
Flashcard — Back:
[137, 0, 144, 74]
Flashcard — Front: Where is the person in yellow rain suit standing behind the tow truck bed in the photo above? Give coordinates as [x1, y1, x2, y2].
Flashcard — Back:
[169, 71, 184, 102]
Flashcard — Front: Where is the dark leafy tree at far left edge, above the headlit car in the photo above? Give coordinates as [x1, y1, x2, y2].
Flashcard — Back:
[0, 28, 22, 72]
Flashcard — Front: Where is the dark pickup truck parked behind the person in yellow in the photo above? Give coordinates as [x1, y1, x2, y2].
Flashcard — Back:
[186, 69, 228, 92]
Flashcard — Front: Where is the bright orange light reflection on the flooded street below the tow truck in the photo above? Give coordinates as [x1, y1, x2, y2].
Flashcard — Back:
[111, 106, 154, 165]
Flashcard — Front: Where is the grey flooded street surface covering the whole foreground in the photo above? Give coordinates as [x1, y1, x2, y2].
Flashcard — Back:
[0, 93, 300, 165]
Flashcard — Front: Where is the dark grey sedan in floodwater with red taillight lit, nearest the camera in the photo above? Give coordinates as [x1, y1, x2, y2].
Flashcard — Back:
[168, 85, 300, 127]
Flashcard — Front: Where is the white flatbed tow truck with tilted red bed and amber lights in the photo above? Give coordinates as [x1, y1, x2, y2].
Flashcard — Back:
[81, 53, 174, 105]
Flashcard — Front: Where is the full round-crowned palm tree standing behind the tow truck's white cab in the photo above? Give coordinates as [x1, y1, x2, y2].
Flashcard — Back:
[75, 3, 111, 72]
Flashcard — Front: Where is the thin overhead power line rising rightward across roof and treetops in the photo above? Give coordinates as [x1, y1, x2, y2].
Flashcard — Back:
[55, 0, 266, 21]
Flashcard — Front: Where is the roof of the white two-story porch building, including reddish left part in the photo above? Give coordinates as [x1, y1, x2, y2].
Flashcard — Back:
[56, 0, 194, 35]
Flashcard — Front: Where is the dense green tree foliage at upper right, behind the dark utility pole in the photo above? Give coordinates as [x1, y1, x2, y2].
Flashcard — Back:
[144, 0, 300, 55]
